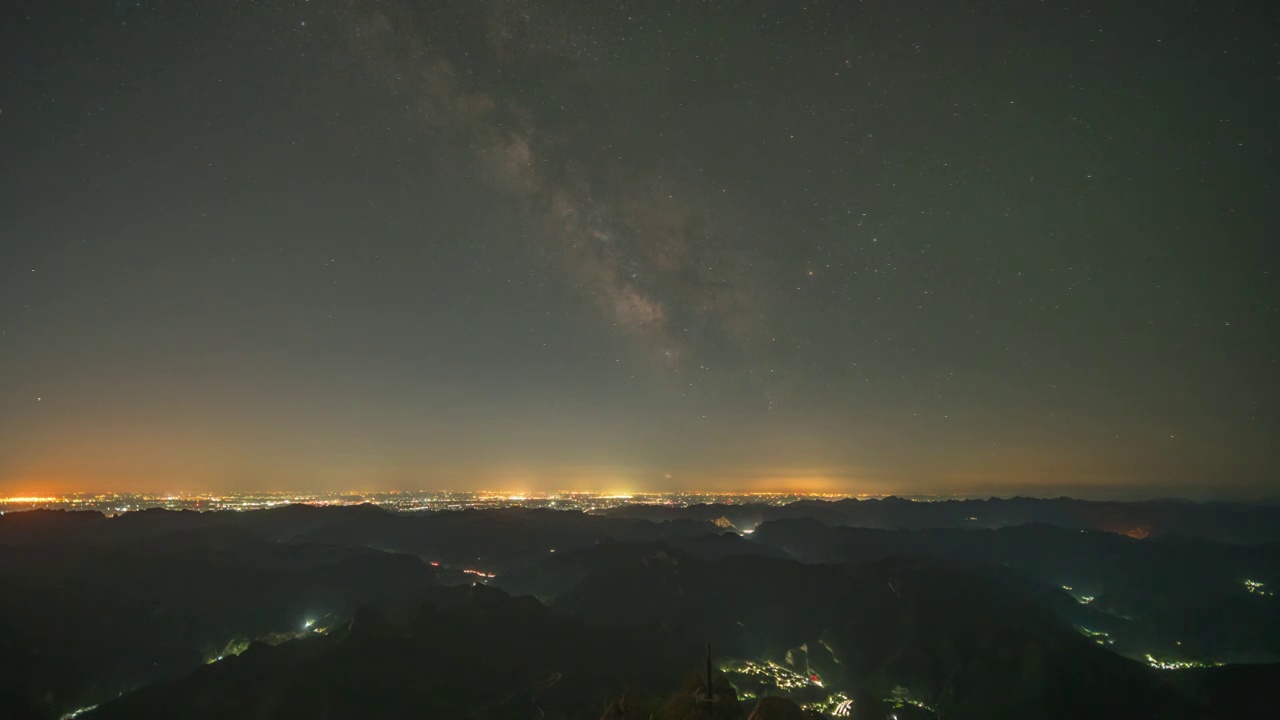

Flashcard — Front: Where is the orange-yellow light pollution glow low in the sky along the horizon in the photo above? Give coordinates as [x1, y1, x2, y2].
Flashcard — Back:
[0, 443, 1259, 498]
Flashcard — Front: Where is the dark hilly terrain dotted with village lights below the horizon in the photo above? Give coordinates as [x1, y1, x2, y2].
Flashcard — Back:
[0, 500, 1280, 720]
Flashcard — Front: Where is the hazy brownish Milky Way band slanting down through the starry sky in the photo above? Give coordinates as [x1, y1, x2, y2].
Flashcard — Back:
[352, 3, 769, 381]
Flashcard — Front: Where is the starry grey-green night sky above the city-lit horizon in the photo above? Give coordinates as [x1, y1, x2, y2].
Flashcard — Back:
[0, 0, 1280, 497]
